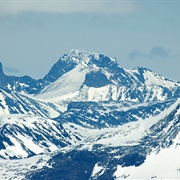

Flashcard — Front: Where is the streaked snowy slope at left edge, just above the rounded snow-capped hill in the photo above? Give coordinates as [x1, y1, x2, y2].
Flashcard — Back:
[0, 89, 61, 118]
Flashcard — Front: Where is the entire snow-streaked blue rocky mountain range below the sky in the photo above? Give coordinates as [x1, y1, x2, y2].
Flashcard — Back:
[0, 49, 180, 180]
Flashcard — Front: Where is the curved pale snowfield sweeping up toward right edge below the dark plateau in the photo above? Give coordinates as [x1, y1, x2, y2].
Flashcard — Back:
[63, 99, 180, 149]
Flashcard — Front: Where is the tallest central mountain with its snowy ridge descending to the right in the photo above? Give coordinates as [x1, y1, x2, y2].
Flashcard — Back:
[36, 49, 180, 105]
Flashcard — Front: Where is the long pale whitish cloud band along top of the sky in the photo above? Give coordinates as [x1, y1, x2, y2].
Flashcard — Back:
[0, 0, 138, 15]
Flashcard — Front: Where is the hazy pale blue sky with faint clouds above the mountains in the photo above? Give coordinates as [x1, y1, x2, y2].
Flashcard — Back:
[0, 0, 180, 81]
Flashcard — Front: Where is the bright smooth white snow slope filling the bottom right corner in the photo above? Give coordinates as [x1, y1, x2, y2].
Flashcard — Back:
[114, 133, 180, 180]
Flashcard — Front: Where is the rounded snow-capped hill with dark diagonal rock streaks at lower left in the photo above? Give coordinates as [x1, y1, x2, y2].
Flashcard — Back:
[0, 114, 78, 158]
